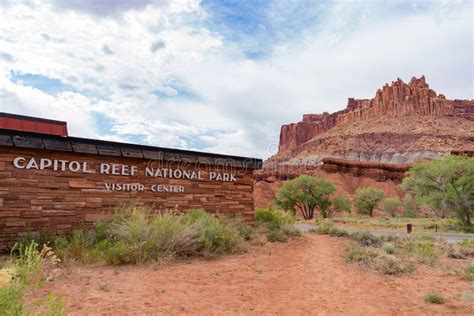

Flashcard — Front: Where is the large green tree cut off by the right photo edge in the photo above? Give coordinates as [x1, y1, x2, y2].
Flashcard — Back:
[401, 155, 474, 225]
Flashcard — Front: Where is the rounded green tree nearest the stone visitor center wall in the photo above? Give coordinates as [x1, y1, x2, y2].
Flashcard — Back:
[276, 175, 336, 219]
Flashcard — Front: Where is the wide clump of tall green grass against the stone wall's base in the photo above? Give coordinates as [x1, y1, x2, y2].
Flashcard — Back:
[55, 205, 246, 265]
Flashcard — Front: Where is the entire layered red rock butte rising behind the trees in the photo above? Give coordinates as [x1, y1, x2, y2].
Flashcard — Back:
[254, 76, 474, 207]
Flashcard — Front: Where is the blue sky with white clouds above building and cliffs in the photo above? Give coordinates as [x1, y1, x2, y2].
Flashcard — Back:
[0, 0, 474, 158]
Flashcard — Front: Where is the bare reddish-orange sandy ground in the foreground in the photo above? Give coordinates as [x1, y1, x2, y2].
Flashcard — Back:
[34, 235, 474, 315]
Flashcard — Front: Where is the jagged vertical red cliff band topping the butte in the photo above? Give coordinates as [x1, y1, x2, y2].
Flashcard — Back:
[279, 76, 474, 153]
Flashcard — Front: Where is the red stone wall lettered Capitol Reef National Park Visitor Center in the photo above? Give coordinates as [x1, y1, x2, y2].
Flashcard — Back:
[0, 131, 261, 249]
